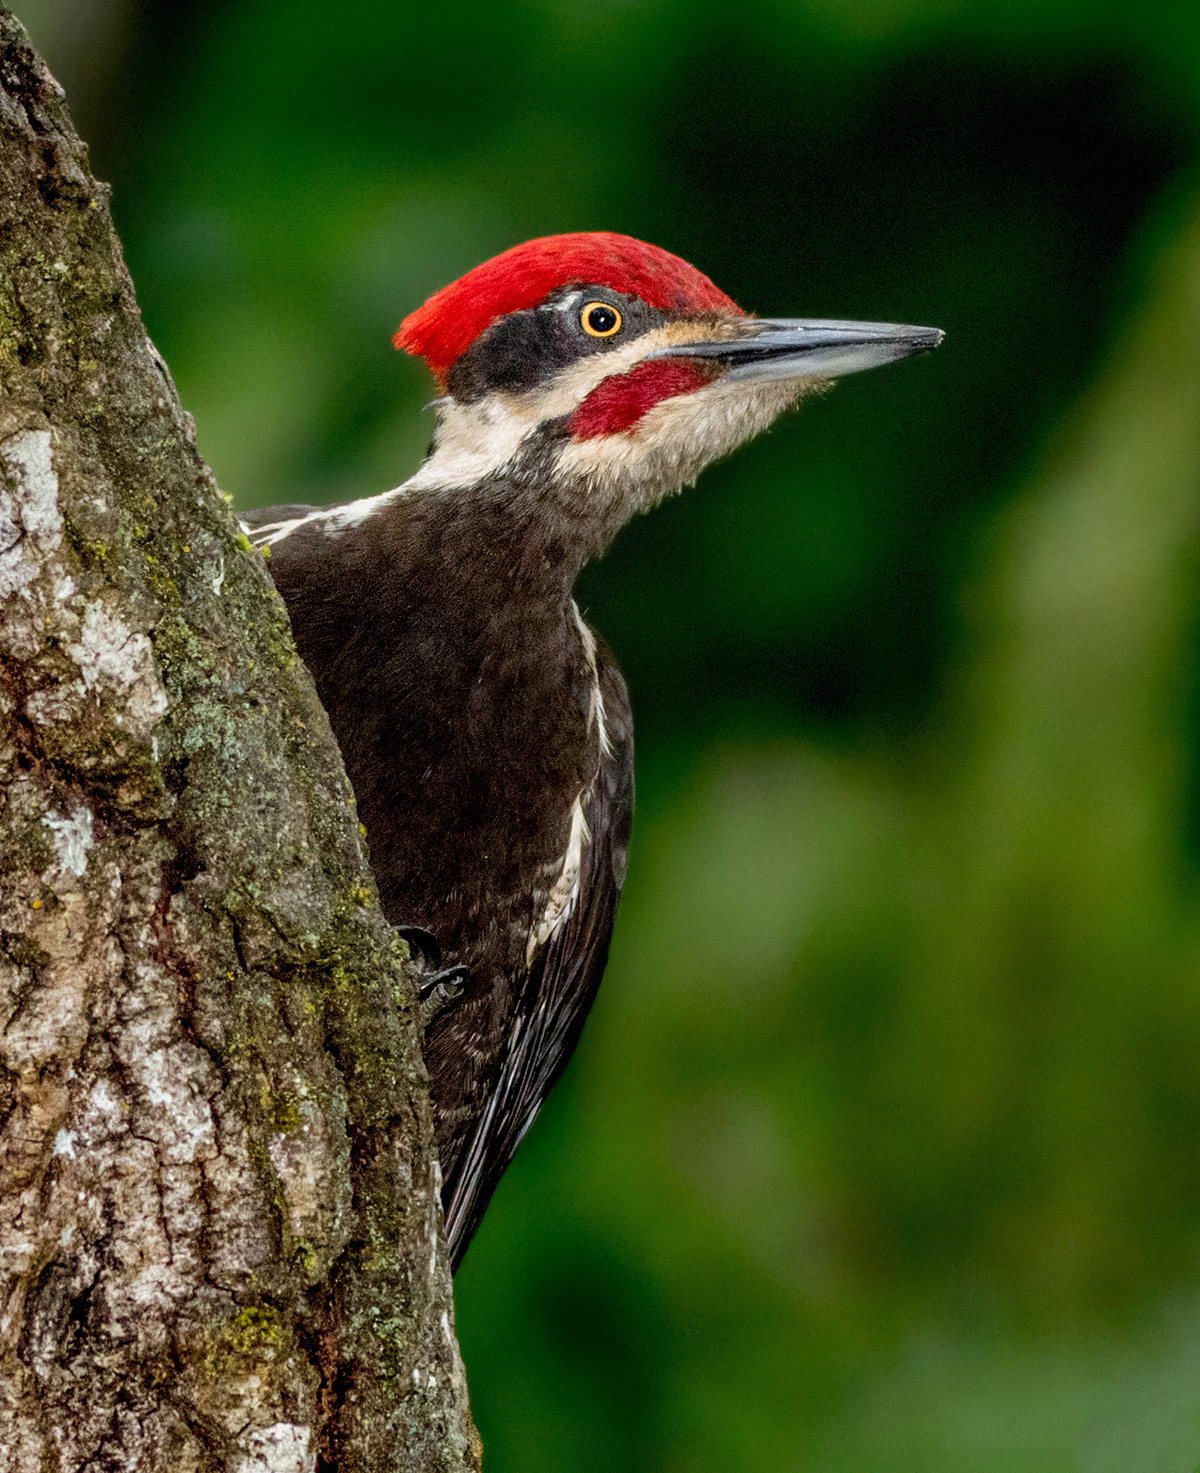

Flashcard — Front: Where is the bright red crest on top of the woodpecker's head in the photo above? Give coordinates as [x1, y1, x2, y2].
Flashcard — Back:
[393, 230, 741, 382]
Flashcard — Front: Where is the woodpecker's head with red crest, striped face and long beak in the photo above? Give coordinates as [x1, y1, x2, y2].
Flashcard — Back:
[395, 231, 942, 542]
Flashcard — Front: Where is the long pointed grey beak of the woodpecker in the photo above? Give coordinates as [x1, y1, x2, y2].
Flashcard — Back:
[648, 317, 945, 382]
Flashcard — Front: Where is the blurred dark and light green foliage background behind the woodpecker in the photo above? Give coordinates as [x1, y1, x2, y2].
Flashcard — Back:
[30, 0, 1200, 1473]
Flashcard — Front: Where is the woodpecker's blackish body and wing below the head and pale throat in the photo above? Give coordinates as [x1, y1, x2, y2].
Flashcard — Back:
[244, 482, 633, 1264]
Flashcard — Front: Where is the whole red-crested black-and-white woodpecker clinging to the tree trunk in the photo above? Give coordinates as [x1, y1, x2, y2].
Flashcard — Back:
[244, 231, 942, 1268]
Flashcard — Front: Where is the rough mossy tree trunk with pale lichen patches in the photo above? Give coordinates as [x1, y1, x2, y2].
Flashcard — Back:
[0, 12, 479, 1473]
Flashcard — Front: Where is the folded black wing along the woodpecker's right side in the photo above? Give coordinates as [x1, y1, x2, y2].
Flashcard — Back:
[442, 651, 633, 1268]
